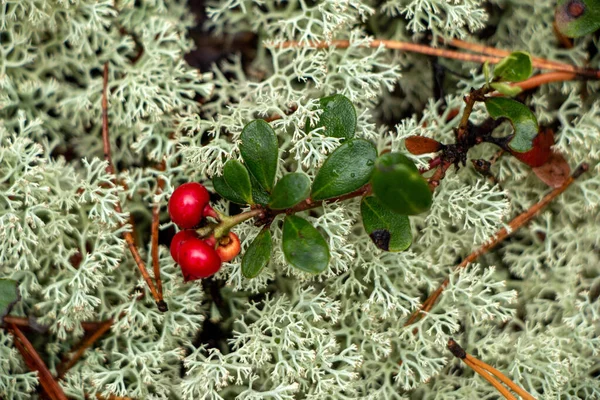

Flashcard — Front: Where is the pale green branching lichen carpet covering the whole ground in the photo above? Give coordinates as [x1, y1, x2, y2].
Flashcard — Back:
[0, 0, 600, 400]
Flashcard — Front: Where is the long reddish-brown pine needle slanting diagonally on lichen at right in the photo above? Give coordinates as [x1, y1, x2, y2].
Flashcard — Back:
[404, 163, 589, 326]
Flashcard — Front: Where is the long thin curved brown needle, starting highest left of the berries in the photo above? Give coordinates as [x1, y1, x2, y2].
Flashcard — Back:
[102, 62, 166, 311]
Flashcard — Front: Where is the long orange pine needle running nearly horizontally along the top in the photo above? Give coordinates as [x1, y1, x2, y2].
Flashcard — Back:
[274, 39, 600, 79]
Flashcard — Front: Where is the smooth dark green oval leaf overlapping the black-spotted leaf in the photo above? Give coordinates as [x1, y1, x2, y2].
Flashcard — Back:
[371, 153, 431, 215]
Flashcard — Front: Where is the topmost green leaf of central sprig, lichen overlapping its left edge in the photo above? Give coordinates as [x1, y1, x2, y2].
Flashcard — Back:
[309, 94, 357, 139]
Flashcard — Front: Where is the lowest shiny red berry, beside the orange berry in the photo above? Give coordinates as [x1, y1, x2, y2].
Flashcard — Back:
[178, 238, 221, 282]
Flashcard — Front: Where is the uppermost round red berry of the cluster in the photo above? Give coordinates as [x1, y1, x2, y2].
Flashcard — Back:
[169, 182, 210, 229]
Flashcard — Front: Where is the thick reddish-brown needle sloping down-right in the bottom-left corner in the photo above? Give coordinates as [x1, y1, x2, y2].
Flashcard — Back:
[9, 324, 67, 400]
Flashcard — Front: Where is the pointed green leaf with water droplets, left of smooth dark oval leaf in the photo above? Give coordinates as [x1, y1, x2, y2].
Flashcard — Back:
[311, 139, 377, 200]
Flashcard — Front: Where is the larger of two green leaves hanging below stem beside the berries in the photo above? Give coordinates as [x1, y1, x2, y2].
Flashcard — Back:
[282, 215, 330, 274]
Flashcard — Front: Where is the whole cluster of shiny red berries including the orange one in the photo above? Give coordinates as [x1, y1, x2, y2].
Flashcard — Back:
[169, 183, 240, 282]
